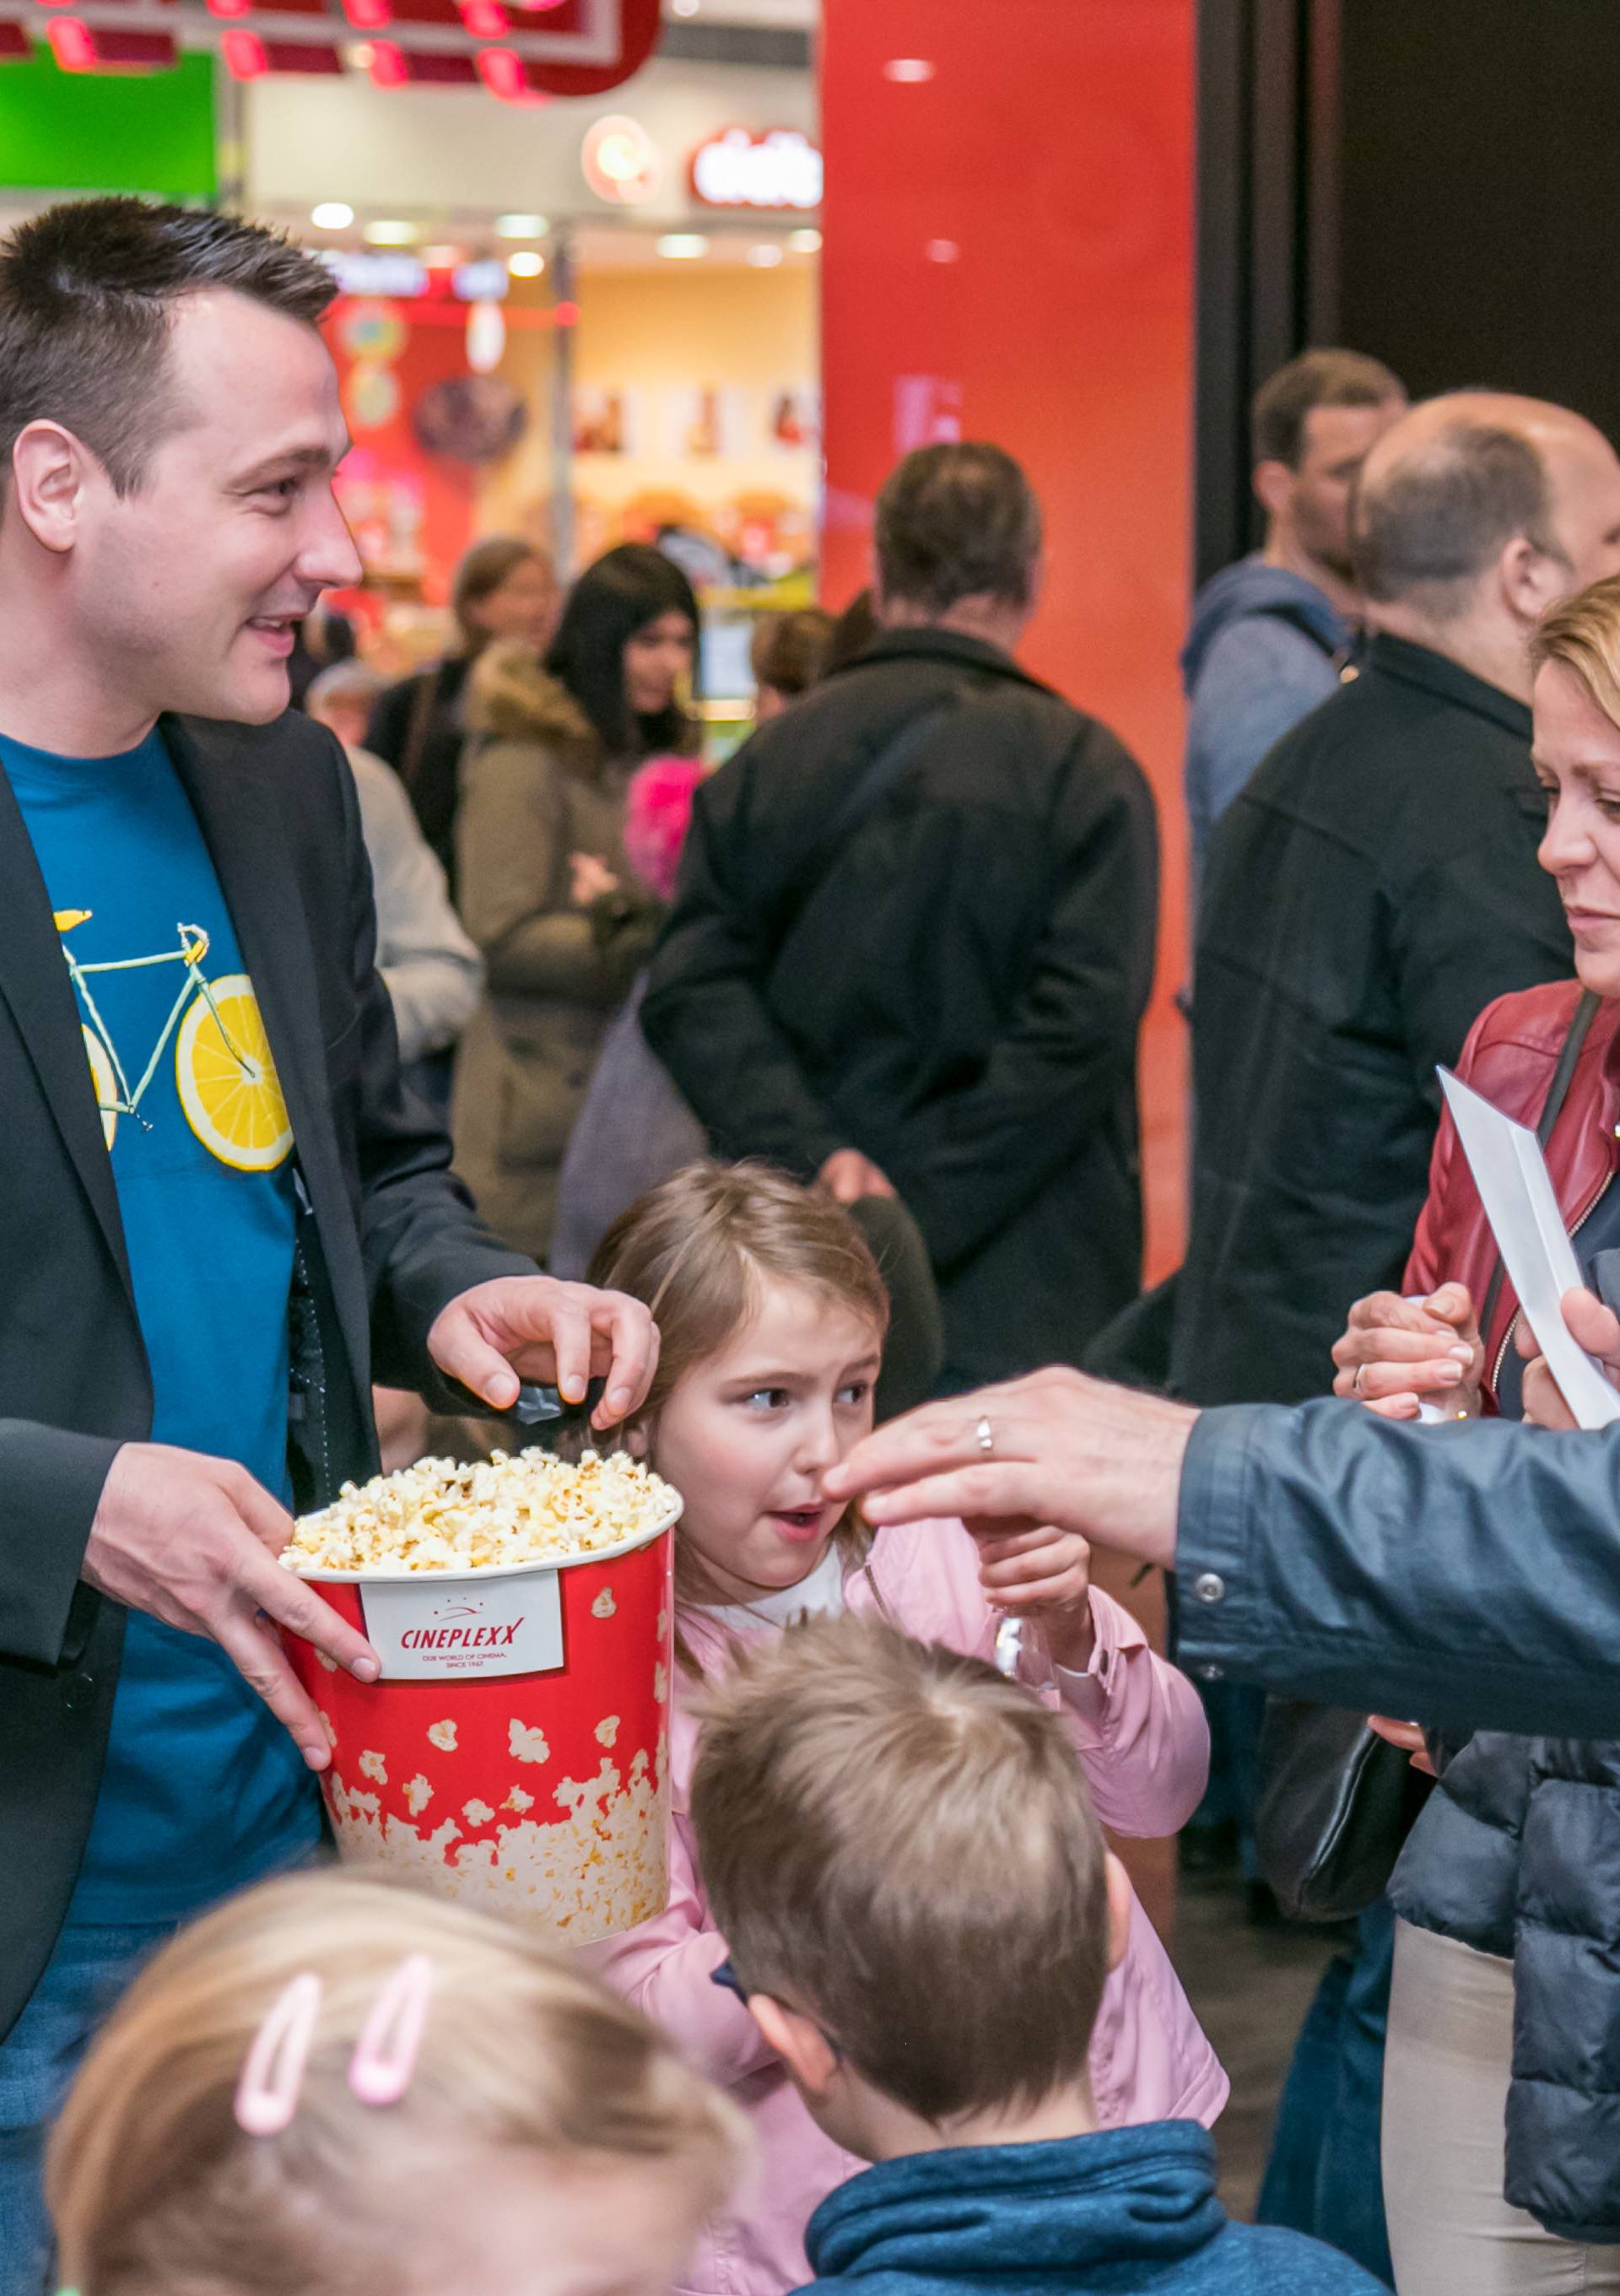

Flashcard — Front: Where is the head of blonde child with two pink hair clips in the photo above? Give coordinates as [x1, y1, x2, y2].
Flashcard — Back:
[46, 1873, 743, 2296]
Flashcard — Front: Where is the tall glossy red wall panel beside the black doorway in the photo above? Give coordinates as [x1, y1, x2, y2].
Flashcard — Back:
[822, 0, 1193, 1270]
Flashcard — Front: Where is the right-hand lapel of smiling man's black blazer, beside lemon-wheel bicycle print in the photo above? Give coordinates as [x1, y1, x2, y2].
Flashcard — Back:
[163, 716, 370, 1398]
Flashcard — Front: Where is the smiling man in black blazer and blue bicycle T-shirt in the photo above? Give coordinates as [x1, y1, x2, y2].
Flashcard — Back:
[0, 200, 656, 2296]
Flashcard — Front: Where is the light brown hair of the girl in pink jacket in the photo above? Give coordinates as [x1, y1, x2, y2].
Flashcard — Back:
[590, 1164, 888, 1634]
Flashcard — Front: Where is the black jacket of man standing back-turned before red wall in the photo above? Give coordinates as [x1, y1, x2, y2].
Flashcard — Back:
[642, 629, 1157, 1385]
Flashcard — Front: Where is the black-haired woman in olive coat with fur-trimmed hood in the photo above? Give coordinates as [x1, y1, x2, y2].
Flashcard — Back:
[454, 542, 698, 1258]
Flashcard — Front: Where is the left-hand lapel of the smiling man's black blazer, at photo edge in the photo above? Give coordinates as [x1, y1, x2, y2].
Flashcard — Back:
[0, 753, 135, 1306]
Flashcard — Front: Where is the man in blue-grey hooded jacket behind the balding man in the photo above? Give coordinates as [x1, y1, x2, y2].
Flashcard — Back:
[1182, 351, 1407, 882]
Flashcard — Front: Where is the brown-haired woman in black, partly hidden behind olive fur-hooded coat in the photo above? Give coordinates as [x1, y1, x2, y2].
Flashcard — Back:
[364, 535, 560, 891]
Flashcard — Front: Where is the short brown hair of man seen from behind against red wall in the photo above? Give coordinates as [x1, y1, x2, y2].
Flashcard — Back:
[874, 440, 1042, 613]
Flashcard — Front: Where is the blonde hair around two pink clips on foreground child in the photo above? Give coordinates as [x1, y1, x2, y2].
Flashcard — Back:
[46, 1873, 741, 2296]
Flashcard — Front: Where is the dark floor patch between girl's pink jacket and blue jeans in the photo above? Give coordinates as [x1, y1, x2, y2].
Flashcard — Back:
[1174, 1878, 1333, 2218]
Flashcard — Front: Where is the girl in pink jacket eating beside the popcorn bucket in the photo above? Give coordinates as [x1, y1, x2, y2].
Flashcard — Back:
[592, 1164, 1228, 2296]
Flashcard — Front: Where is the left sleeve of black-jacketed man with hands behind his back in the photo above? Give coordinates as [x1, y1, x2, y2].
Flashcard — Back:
[640, 755, 851, 1180]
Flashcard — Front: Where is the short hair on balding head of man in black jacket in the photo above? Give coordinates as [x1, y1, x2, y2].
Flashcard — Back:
[1349, 416, 1560, 622]
